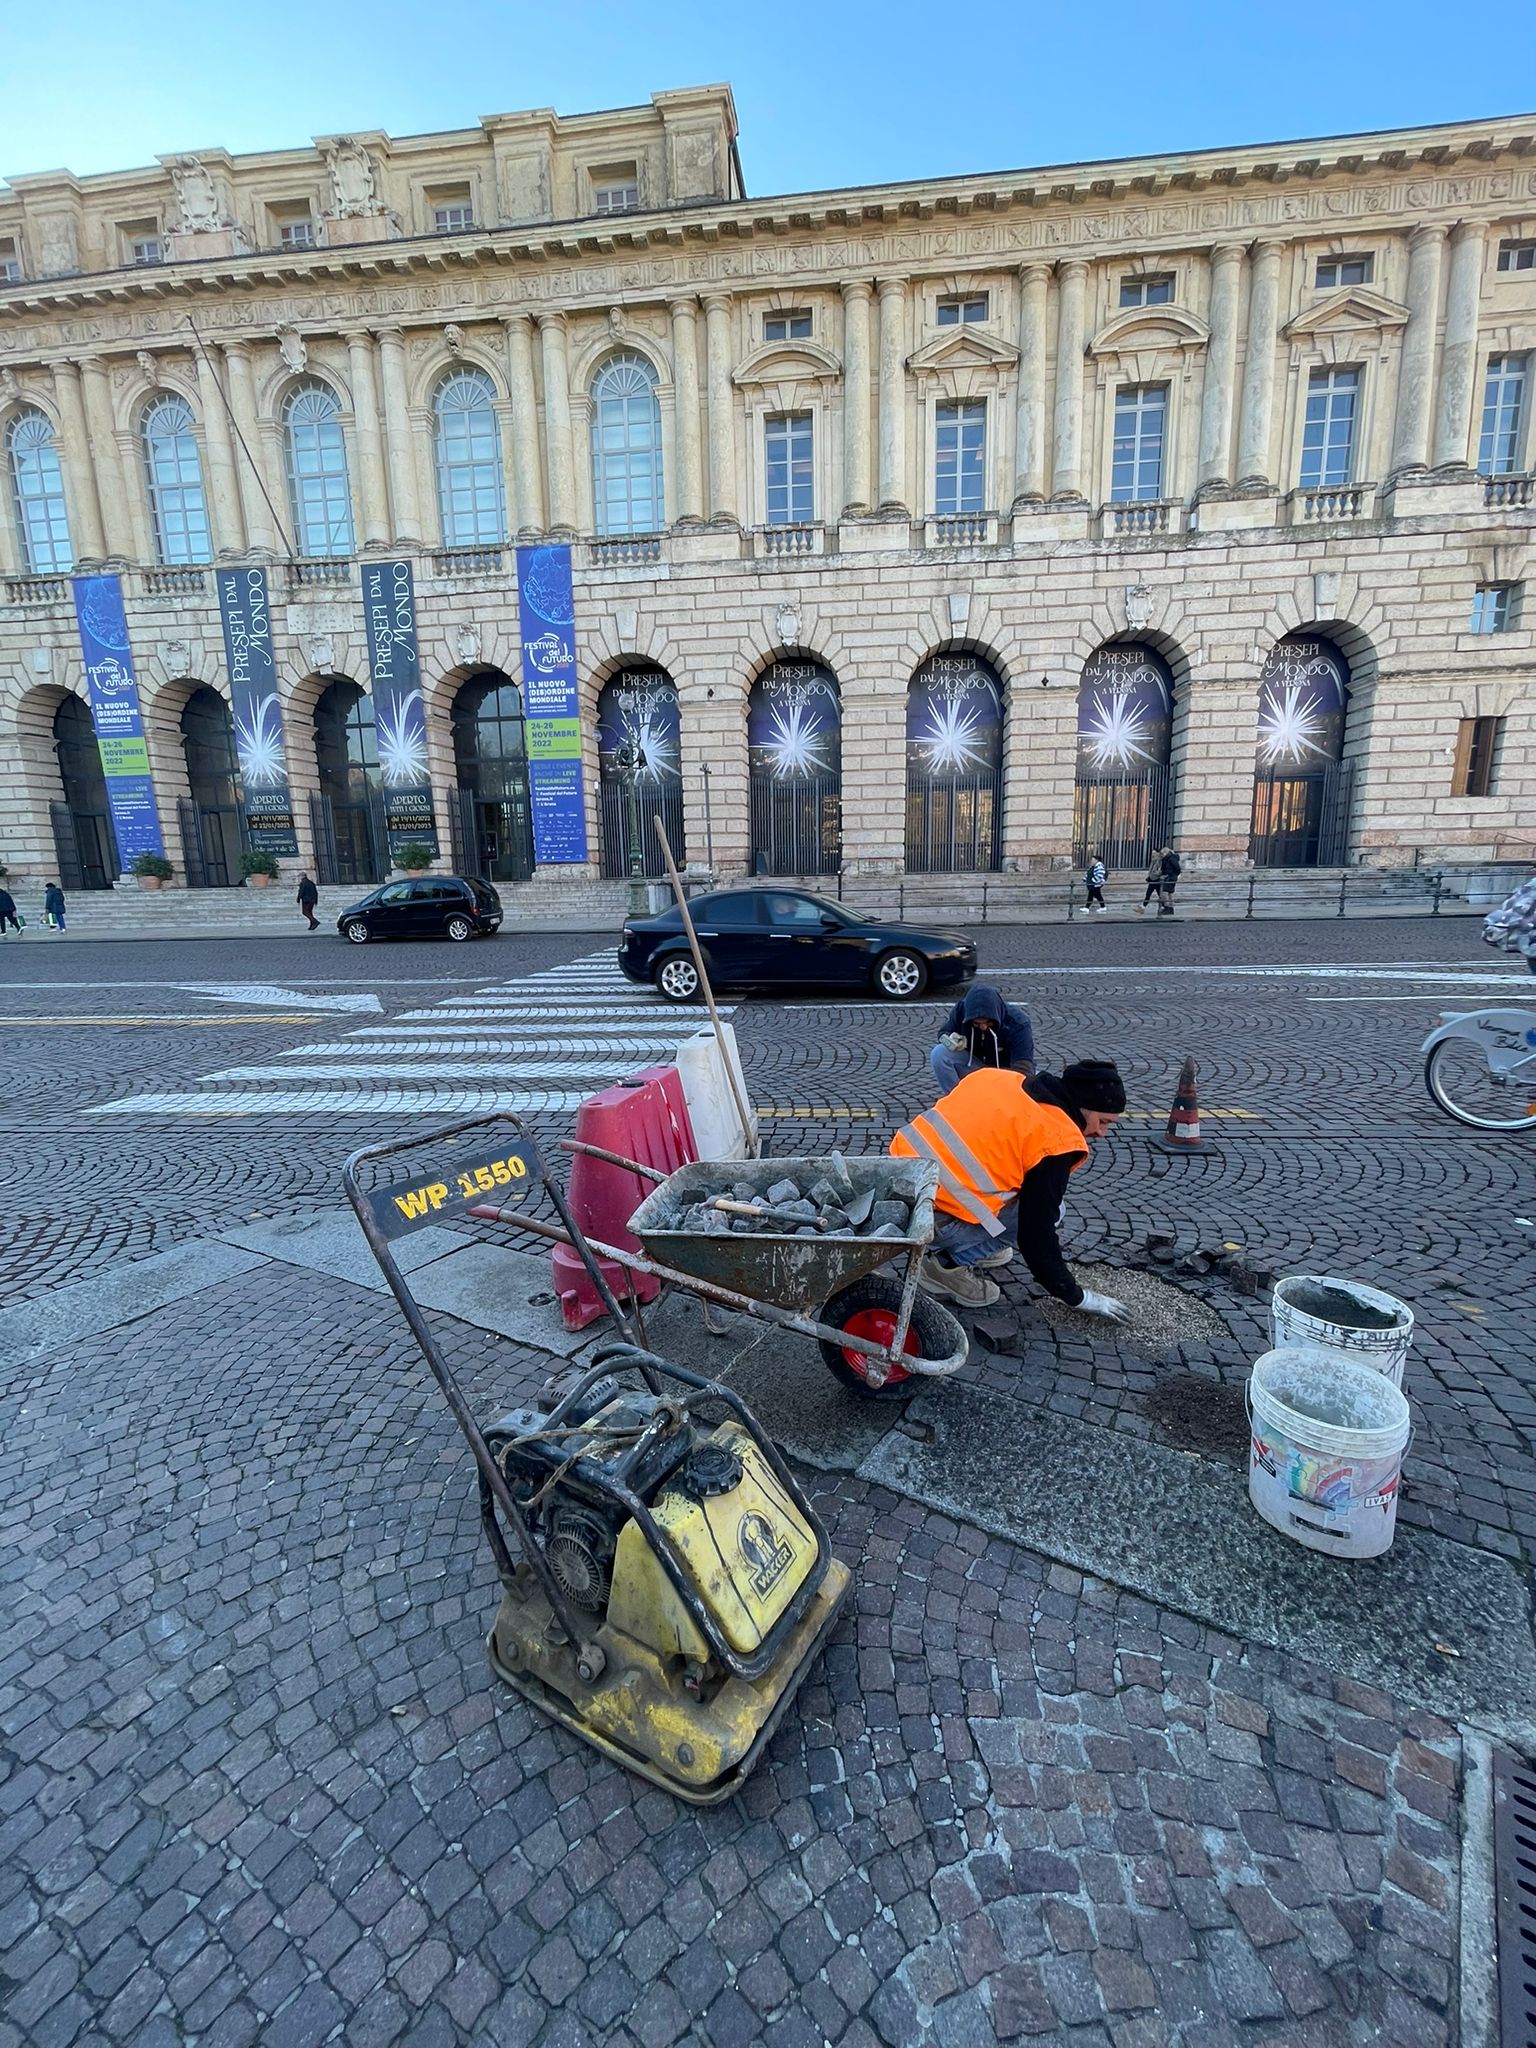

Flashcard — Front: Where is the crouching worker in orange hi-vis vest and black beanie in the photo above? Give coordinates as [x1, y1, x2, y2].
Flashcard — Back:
[891, 1059, 1128, 1323]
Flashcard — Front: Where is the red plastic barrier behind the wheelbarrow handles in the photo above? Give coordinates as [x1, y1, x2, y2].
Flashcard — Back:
[553, 1067, 698, 1329]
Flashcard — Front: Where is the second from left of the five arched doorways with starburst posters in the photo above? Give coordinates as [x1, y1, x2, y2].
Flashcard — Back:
[748, 659, 842, 874]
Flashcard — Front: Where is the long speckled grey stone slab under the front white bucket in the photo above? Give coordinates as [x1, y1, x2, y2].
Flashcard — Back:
[858, 1384, 1536, 1733]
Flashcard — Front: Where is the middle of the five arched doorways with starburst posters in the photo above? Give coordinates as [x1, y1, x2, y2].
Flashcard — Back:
[907, 653, 1004, 874]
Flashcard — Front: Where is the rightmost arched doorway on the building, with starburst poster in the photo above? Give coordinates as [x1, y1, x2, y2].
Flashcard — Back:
[1247, 633, 1352, 868]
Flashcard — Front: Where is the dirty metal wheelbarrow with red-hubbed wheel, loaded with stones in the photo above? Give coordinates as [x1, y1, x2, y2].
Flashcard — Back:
[469, 1139, 971, 1395]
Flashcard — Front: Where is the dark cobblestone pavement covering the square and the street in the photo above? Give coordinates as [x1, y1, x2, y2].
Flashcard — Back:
[0, 922, 1534, 2048]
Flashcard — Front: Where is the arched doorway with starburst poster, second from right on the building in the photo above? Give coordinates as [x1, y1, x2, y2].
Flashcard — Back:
[1071, 641, 1174, 868]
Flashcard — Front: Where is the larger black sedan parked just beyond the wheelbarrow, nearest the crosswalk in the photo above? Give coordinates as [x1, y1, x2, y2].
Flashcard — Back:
[618, 885, 977, 1004]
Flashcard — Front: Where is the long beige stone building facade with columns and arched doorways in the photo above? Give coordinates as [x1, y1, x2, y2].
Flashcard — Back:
[0, 88, 1536, 887]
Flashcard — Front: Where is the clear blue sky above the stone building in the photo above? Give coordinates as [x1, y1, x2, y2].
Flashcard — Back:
[0, 0, 1536, 195]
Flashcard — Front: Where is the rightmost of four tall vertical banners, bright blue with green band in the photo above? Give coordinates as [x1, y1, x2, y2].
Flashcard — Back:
[518, 547, 588, 866]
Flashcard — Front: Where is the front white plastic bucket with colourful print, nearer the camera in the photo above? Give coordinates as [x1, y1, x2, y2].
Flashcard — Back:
[1247, 1346, 1413, 1556]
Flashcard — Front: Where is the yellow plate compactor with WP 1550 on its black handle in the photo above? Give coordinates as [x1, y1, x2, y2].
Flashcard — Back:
[342, 1116, 850, 1804]
